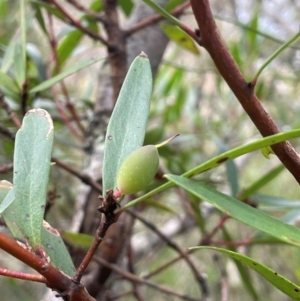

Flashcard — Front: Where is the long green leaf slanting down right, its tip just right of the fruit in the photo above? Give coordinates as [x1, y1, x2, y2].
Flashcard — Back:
[166, 175, 300, 246]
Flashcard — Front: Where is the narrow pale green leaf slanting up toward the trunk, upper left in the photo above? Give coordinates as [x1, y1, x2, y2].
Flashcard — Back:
[29, 57, 102, 93]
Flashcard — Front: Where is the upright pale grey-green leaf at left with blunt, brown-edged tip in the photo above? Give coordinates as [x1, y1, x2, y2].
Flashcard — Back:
[8, 109, 53, 247]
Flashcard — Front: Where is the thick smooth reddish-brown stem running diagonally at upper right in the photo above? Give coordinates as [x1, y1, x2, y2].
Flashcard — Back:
[191, 0, 300, 183]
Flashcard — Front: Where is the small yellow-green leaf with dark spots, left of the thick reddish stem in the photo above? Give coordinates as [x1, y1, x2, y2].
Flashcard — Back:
[161, 23, 200, 55]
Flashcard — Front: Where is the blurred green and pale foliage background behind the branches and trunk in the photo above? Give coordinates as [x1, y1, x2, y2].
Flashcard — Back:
[0, 0, 300, 301]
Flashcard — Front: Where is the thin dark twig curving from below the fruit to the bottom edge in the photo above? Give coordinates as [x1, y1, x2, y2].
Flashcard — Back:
[126, 209, 208, 299]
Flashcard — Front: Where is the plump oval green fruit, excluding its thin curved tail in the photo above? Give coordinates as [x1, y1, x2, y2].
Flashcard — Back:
[117, 145, 159, 195]
